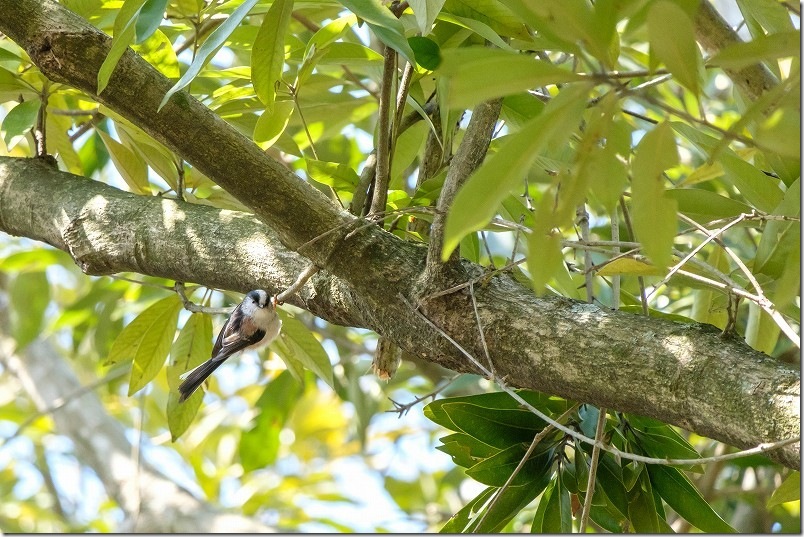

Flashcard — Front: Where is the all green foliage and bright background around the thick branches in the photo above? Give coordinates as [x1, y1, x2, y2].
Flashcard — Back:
[0, 0, 800, 532]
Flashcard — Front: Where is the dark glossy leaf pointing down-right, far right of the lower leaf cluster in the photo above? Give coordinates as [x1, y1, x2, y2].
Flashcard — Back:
[647, 464, 736, 533]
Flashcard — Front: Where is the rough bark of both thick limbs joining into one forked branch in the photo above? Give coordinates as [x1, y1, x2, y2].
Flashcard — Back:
[0, 0, 800, 468]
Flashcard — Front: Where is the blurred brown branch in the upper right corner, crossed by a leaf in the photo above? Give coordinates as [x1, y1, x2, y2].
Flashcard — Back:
[695, 0, 778, 100]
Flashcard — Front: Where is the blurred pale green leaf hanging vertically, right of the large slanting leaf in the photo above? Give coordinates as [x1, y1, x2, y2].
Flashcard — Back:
[631, 123, 678, 269]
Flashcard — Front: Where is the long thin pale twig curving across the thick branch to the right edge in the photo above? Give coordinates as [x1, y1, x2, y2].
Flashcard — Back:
[398, 293, 801, 466]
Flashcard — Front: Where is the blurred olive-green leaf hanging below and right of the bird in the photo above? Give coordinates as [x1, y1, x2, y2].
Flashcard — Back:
[239, 371, 304, 472]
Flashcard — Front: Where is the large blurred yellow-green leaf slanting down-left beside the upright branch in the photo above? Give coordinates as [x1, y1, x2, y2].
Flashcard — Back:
[441, 84, 589, 261]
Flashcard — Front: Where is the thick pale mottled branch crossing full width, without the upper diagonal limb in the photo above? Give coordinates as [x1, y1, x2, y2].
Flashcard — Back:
[0, 158, 800, 468]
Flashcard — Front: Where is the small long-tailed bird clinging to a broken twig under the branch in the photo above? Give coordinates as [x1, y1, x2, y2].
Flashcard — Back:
[179, 289, 282, 403]
